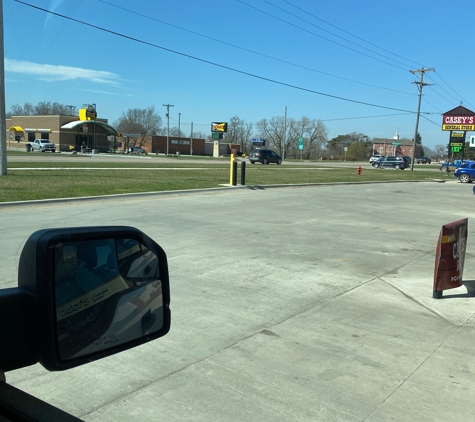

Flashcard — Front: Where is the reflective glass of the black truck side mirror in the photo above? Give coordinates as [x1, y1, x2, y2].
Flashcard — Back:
[53, 239, 163, 360]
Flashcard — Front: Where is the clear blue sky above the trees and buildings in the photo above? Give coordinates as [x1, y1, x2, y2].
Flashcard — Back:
[3, 0, 475, 148]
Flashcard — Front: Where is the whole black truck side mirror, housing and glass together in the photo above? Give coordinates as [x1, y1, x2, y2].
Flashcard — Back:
[0, 226, 171, 371]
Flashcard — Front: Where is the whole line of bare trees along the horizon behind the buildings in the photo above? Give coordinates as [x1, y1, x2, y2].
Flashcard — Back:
[6, 102, 446, 160]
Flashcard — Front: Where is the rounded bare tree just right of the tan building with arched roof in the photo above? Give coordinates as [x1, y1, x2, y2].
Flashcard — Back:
[114, 106, 162, 146]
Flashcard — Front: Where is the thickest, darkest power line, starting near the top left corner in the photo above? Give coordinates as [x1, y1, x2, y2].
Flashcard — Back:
[14, 0, 413, 113]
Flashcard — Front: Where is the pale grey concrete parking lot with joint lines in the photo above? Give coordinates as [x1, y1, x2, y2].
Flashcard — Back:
[0, 177, 475, 422]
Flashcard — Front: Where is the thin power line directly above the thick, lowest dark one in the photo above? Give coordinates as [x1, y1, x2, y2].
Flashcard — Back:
[97, 0, 413, 95]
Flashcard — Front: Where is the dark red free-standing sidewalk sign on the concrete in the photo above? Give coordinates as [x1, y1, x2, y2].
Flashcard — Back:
[432, 218, 468, 299]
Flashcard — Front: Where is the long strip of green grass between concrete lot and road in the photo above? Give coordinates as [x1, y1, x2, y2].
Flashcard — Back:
[0, 154, 442, 202]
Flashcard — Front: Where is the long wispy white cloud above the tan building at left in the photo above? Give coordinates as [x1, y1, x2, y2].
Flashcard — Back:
[5, 58, 119, 85]
